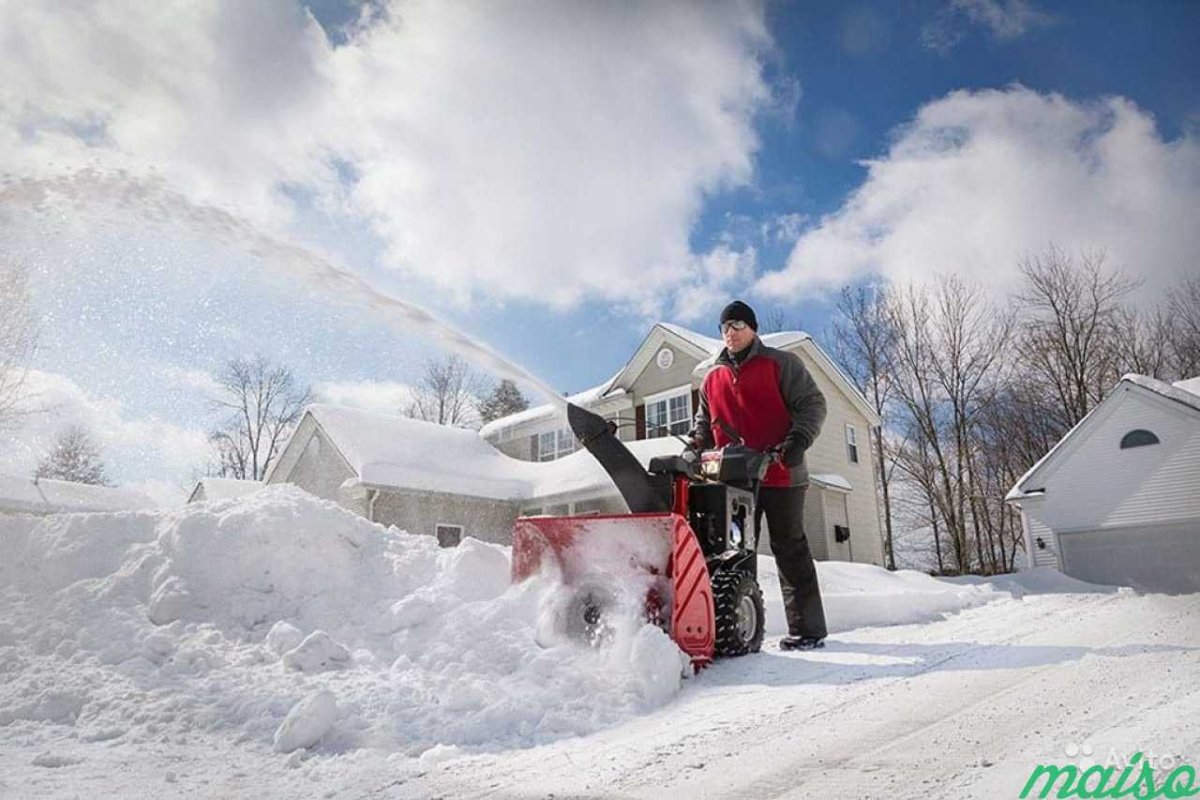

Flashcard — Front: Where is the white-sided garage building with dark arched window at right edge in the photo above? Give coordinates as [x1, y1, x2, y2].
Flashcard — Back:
[1007, 374, 1200, 591]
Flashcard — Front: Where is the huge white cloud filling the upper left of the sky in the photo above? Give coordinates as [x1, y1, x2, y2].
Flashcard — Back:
[0, 0, 772, 306]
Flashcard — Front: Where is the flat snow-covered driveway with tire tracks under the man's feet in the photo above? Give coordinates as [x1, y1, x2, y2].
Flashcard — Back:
[386, 585, 1200, 798]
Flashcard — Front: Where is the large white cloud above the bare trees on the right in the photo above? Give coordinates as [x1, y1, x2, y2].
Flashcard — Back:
[757, 86, 1200, 303]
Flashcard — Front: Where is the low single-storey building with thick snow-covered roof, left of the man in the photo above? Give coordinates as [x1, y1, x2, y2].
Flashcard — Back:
[265, 404, 682, 545]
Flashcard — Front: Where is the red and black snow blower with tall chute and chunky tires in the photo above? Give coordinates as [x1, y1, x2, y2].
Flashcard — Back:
[512, 404, 769, 669]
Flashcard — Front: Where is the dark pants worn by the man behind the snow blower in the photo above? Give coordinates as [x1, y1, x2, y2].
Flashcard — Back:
[755, 486, 827, 638]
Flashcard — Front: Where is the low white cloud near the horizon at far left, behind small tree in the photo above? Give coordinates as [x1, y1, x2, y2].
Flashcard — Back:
[0, 371, 209, 497]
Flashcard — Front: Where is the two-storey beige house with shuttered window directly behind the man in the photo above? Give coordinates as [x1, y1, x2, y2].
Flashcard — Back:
[480, 323, 883, 565]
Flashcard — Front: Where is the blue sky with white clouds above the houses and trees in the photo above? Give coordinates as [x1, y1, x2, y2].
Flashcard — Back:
[0, 0, 1200, 501]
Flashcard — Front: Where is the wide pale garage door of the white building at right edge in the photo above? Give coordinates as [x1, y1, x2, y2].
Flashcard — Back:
[1058, 521, 1200, 593]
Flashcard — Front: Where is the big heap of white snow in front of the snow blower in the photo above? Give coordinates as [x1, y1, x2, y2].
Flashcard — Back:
[0, 487, 682, 756]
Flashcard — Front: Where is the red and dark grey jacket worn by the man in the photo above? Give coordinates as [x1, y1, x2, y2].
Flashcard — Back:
[692, 338, 826, 486]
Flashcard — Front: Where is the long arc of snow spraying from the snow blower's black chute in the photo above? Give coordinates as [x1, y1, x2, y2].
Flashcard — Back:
[0, 169, 565, 405]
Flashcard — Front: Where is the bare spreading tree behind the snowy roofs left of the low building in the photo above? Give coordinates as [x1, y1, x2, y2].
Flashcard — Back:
[209, 356, 312, 481]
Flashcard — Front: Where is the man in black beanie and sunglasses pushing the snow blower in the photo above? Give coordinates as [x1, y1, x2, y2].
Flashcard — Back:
[691, 300, 827, 650]
